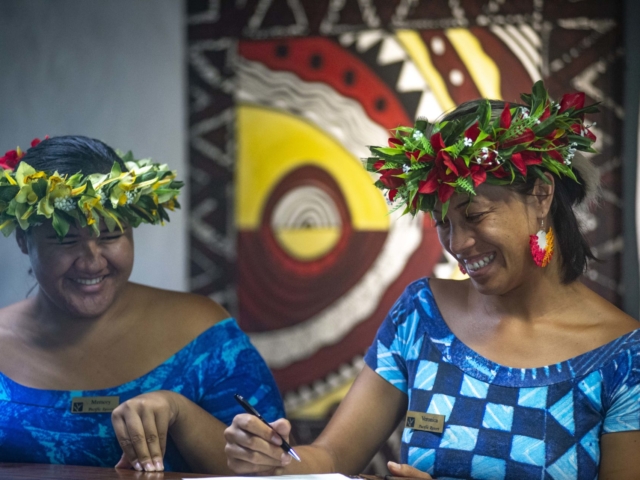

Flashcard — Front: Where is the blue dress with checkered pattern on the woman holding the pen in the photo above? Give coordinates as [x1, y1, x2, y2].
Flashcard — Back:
[365, 279, 640, 480]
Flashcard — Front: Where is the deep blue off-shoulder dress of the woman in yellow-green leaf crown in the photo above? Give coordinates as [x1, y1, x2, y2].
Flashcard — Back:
[0, 319, 284, 472]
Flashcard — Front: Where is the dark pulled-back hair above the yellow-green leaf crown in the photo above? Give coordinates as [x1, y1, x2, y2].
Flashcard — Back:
[20, 135, 124, 175]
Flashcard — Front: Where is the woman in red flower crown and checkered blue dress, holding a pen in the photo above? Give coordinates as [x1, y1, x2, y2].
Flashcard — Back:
[225, 82, 640, 480]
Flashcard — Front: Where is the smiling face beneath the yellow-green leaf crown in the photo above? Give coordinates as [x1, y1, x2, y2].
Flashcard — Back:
[18, 224, 133, 318]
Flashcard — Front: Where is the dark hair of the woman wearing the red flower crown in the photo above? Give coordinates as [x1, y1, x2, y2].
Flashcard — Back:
[440, 100, 596, 284]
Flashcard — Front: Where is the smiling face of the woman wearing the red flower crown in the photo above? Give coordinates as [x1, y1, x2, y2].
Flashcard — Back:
[434, 184, 546, 295]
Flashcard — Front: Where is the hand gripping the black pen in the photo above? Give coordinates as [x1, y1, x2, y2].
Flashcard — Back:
[224, 413, 291, 475]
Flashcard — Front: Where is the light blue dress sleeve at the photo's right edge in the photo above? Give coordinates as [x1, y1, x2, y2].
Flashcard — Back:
[602, 349, 640, 433]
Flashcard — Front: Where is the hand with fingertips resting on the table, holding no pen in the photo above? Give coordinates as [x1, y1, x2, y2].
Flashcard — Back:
[111, 390, 181, 472]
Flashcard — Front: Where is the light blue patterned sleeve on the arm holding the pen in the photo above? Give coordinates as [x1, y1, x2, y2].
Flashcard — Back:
[364, 289, 418, 393]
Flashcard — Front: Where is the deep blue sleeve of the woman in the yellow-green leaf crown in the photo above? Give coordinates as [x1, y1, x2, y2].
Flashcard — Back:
[195, 320, 285, 425]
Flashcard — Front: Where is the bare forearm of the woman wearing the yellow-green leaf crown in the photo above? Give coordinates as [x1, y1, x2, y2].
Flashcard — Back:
[169, 394, 233, 475]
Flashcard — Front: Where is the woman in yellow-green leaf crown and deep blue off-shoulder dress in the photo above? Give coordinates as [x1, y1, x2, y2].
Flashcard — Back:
[0, 136, 283, 474]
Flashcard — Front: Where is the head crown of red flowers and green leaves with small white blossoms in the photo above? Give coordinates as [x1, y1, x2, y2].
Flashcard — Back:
[364, 81, 598, 216]
